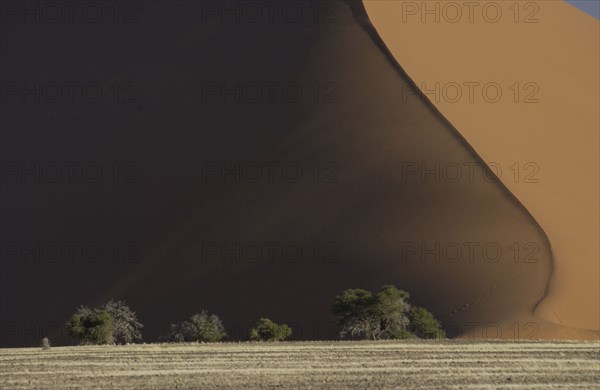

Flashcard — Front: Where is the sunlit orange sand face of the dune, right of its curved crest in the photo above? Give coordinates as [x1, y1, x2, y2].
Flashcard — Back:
[364, 0, 600, 329]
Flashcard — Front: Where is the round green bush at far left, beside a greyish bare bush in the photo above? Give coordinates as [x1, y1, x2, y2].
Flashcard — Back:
[67, 306, 114, 345]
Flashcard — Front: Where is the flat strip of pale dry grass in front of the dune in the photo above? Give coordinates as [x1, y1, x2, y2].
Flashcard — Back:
[0, 341, 600, 389]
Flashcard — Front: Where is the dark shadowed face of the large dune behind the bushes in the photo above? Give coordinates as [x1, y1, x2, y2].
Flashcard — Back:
[0, 1, 590, 345]
